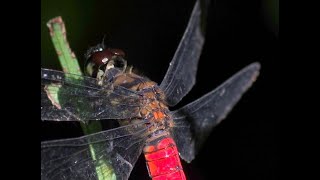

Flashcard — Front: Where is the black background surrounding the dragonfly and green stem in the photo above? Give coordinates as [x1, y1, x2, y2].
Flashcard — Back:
[41, 0, 280, 179]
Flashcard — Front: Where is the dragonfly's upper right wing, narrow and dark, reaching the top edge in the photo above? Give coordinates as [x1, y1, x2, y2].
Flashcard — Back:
[160, 0, 208, 106]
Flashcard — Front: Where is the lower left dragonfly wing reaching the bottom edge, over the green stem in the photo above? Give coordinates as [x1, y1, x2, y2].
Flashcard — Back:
[41, 122, 147, 180]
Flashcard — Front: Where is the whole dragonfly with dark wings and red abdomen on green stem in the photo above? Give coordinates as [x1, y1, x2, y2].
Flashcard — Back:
[41, 1, 260, 180]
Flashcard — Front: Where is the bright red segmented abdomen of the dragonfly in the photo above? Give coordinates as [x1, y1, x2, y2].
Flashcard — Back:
[143, 137, 186, 180]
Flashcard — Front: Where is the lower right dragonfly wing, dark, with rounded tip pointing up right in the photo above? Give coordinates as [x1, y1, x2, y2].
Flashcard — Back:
[172, 63, 260, 162]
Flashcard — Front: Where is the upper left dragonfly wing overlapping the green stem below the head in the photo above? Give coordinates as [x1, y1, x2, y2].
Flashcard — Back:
[41, 69, 143, 121]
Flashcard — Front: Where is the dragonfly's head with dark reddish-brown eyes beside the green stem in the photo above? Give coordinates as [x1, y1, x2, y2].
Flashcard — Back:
[85, 44, 127, 78]
